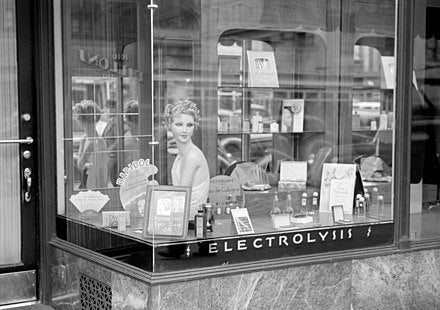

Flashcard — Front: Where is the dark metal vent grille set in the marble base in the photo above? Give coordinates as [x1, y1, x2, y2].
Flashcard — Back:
[79, 274, 112, 310]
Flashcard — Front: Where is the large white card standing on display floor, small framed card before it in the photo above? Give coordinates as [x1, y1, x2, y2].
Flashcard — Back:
[319, 163, 356, 214]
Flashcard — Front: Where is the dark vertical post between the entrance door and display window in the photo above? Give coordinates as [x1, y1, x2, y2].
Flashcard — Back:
[24, 0, 57, 304]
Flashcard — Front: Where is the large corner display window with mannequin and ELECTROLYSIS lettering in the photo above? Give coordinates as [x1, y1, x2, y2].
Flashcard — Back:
[57, 0, 396, 272]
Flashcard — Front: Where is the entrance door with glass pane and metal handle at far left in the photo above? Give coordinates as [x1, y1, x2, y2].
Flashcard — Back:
[0, 0, 38, 308]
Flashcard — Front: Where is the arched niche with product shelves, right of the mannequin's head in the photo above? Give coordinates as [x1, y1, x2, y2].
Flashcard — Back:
[216, 30, 328, 174]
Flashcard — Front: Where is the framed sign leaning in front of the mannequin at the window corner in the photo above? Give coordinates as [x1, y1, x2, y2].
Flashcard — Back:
[142, 185, 191, 239]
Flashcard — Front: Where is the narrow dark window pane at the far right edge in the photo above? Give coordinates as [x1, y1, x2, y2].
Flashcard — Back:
[410, 1, 440, 241]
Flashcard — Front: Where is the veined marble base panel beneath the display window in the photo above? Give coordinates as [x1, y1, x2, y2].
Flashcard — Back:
[52, 249, 440, 310]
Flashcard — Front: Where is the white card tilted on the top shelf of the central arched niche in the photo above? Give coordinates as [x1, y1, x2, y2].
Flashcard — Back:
[247, 51, 279, 87]
